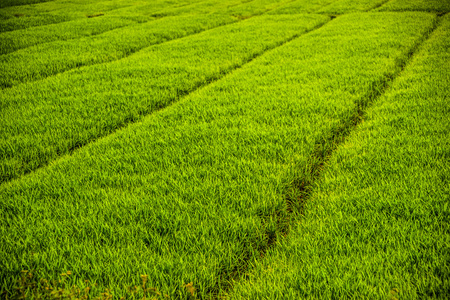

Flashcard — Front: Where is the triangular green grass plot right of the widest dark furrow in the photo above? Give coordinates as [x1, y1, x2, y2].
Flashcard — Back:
[231, 11, 450, 299]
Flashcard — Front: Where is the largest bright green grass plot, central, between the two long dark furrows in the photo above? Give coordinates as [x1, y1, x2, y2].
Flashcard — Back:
[0, 13, 435, 298]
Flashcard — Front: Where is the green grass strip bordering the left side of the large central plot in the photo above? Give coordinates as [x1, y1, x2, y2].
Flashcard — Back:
[0, 15, 328, 181]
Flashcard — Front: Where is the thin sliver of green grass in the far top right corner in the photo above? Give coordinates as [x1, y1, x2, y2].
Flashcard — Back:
[379, 0, 450, 12]
